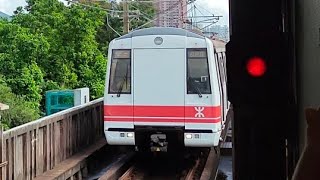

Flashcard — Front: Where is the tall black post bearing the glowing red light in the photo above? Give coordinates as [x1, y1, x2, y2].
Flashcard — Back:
[227, 0, 298, 180]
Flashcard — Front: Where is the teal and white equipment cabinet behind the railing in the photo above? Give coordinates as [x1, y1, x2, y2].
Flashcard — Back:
[46, 88, 89, 116]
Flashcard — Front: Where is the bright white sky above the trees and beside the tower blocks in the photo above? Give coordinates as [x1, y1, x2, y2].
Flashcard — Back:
[0, 0, 229, 25]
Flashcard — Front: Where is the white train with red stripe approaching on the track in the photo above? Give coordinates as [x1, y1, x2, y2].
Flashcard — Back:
[104, 27, 229, 151]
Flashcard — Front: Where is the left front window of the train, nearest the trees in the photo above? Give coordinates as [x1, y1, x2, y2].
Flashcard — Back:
[109, 50, 131, 94]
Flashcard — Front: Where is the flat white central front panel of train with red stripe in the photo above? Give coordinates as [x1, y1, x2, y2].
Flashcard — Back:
[133, 49, 185, 126]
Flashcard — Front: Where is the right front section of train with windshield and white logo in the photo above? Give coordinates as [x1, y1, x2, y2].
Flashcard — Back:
[185, 48, 212, 126]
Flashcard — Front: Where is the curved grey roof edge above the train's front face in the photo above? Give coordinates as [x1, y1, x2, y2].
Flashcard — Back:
[116, 27, 205, 40]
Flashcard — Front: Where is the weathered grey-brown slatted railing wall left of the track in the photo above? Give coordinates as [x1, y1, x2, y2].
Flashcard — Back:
[0, 98, 103, 180]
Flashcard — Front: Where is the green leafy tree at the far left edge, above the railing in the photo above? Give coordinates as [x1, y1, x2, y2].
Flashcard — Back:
[0, 21, 48, 109]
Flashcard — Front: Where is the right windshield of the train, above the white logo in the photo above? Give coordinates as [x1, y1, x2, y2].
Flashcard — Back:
[187, 49, 211, 94]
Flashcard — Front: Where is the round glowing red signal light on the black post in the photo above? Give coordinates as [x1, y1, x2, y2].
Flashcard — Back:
[247, 57, 267, 77]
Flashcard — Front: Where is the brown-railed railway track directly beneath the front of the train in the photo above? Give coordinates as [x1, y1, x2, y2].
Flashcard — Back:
[95, 148, 213, 180]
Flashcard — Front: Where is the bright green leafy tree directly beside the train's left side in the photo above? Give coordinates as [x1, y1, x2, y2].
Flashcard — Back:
[8, 0, 106, 98]
